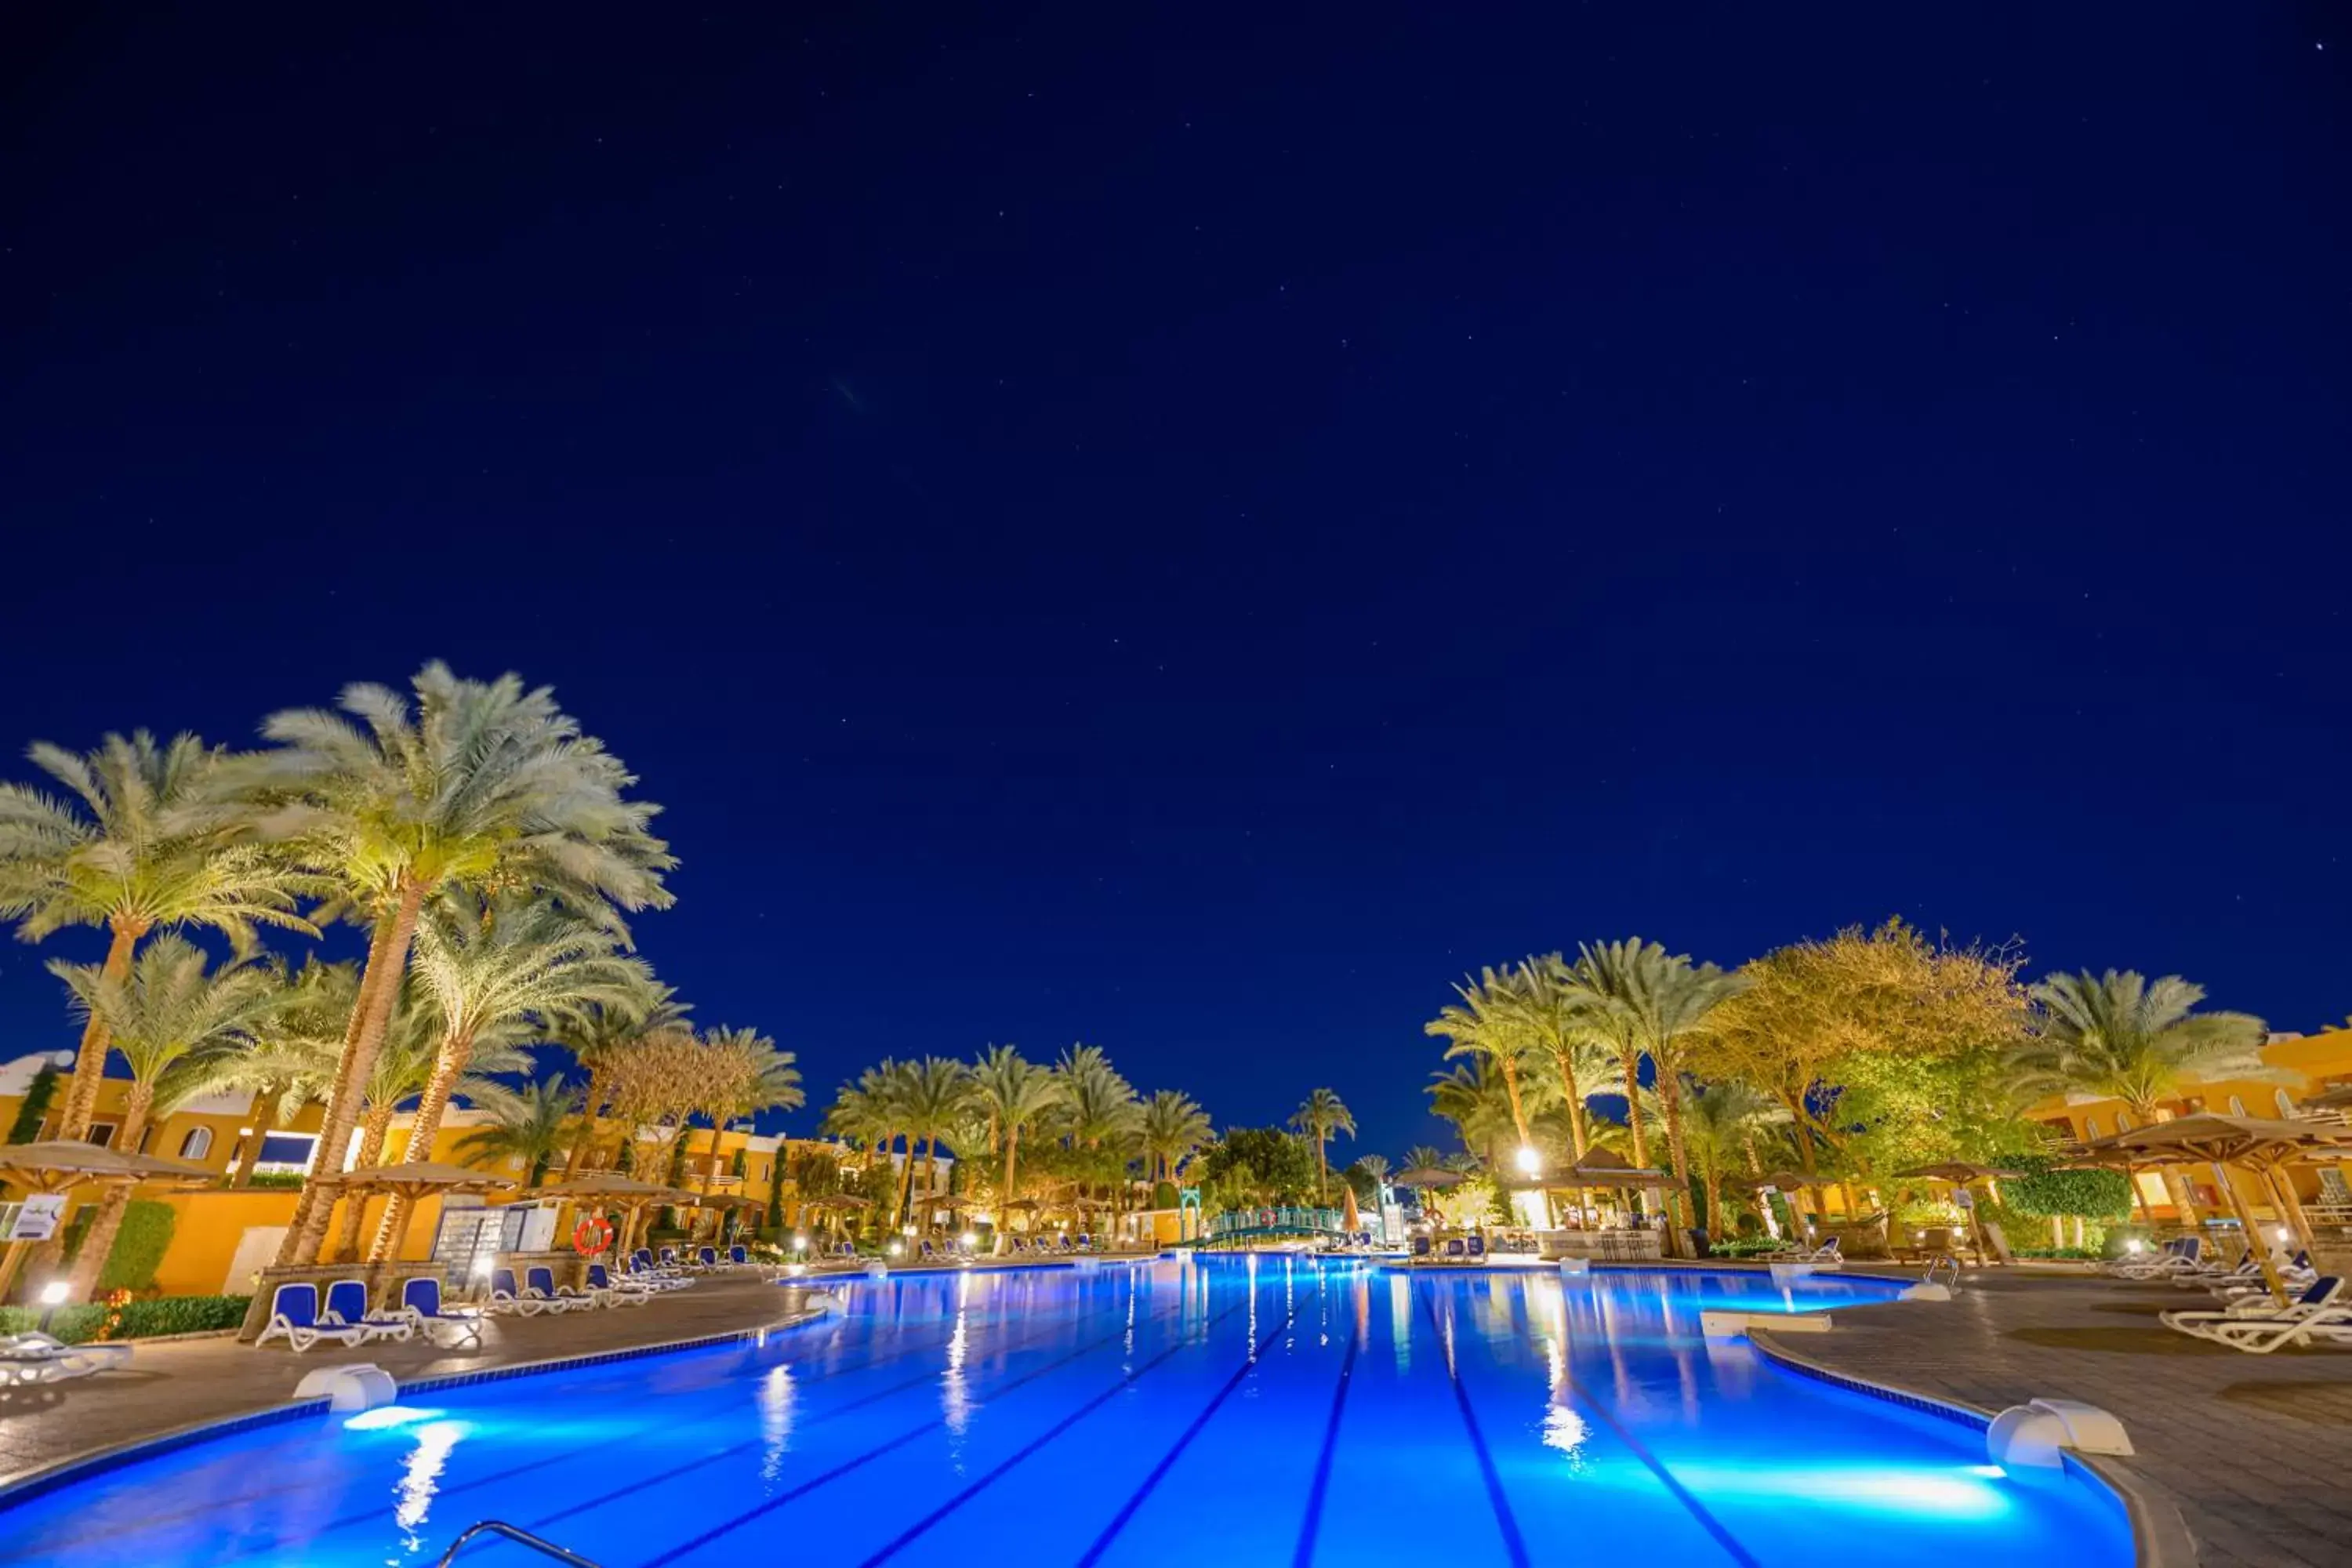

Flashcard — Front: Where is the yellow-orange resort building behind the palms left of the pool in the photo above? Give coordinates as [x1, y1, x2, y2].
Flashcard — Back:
[0, 1051, 936, 1295]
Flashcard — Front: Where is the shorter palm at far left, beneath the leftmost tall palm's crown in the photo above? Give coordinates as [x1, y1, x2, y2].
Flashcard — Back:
[49, 935, 287, 1300]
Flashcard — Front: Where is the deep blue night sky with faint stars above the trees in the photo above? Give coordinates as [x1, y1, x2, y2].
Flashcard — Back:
[0, 5, 2352, 1156]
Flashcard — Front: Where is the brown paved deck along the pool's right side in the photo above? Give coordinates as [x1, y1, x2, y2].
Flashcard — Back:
[1766, 1272, 2352, 1568]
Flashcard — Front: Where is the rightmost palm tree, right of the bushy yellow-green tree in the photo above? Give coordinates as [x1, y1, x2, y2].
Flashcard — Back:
[2009, 968, 2286, 1220]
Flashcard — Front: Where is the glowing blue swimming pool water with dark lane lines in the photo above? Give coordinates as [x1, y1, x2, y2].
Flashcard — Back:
[0, 1258, 2131, 1568]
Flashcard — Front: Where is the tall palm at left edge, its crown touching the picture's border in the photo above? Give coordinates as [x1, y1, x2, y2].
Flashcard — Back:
[0, 729, 320, 1140]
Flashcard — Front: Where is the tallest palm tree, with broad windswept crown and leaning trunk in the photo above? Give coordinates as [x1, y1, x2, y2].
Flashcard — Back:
[238, 661, 675, 1265]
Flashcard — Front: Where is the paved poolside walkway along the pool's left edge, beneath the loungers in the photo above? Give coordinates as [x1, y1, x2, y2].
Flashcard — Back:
[0, 1276, 811, 1486]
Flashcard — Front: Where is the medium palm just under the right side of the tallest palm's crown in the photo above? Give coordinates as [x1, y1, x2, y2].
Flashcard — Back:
[369, 888, 654, 1262]
